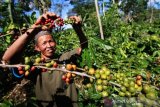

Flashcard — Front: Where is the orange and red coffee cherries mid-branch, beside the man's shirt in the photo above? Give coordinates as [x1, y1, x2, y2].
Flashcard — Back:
[62, 64, 77, 84]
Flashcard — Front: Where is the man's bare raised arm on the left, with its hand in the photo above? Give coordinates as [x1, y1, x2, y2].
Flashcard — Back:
[2, 12, 56, 62]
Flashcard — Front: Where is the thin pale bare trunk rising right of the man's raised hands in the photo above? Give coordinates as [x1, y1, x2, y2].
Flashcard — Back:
[95, 0, 104, 40]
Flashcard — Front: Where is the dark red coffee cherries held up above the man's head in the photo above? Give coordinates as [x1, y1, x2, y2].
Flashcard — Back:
[35, 16, 64, 29]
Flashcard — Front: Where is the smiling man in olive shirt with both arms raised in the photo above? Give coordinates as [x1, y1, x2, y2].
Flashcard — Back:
[2, 12, 88, 107]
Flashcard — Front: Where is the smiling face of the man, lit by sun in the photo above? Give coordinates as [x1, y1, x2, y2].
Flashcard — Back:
[35, 35, 56, 59]
